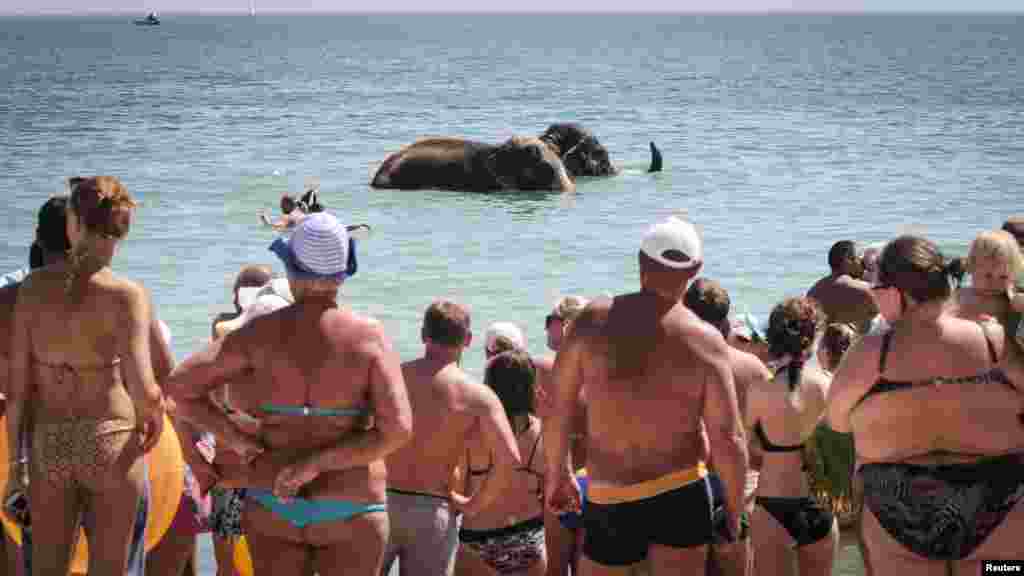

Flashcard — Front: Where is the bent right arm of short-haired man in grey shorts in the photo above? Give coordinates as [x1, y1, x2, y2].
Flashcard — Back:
[460, 384, 522, 517]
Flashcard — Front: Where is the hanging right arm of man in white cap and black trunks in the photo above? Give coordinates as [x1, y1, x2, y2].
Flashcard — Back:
[701, 340, 748, 535]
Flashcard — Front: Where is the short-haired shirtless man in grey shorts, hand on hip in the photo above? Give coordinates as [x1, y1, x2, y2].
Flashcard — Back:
[381, 300, 520, 576]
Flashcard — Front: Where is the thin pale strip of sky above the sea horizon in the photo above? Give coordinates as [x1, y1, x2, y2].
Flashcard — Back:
[0, 0, 1024, 14]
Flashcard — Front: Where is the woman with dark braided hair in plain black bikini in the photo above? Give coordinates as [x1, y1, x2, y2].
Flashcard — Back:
[746, 297, 839, 576]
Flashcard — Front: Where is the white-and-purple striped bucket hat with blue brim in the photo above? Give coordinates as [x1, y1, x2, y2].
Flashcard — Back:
[270, 212, 357, 282]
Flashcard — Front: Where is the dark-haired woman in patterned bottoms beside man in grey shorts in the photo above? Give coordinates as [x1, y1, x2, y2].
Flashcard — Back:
[453, 348, 548, 576]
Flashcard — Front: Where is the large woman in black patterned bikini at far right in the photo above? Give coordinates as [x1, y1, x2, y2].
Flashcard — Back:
[827, 236, 1024, 575]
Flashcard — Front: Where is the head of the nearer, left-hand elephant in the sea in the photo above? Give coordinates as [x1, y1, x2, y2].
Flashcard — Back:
[486, 136, 575, 192]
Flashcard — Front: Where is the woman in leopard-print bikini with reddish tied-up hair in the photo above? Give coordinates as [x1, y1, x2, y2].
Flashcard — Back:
[5, 176, 164, 576]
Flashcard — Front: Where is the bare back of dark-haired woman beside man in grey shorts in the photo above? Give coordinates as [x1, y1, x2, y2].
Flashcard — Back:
[463, 412, 544, 530]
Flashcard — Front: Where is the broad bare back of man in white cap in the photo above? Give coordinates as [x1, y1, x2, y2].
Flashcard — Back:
[575, 294, 720, 484]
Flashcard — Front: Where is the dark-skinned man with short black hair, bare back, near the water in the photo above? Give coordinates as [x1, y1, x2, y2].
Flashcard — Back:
[807, 240, 879, 334]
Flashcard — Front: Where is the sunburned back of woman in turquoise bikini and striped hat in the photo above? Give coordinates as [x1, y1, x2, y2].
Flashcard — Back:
[218, 304, 385, 498]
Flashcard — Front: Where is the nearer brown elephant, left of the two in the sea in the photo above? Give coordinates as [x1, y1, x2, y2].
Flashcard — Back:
[370, 136, 575, 192]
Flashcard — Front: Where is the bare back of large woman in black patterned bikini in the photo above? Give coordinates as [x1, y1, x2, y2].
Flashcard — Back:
[850, 318, 1024, 461]
